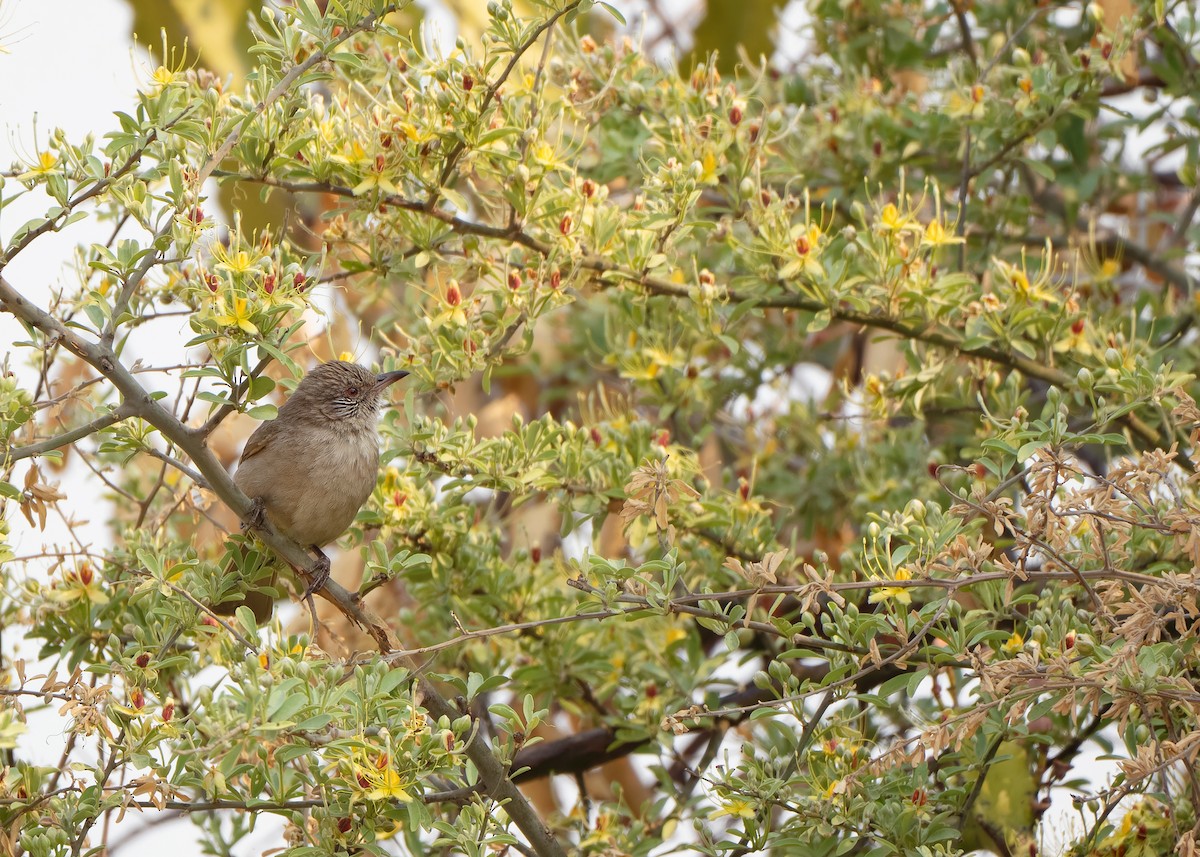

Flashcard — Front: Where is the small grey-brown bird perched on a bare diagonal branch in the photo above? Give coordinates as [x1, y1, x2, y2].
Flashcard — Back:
[233, 360, 409, 604]
